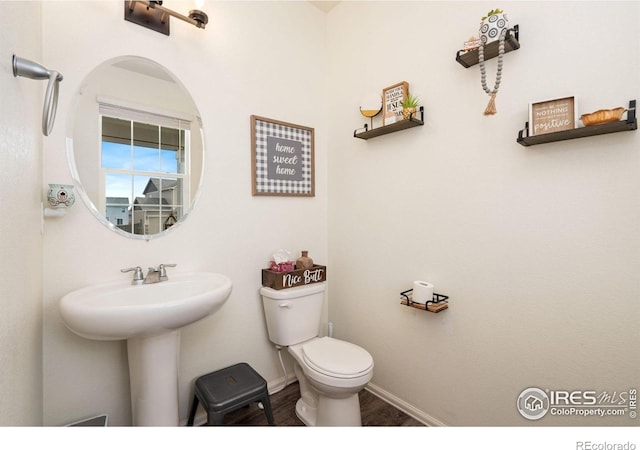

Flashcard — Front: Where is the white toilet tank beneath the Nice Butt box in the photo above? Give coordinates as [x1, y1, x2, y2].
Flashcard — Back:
[260, 281, 326, 346]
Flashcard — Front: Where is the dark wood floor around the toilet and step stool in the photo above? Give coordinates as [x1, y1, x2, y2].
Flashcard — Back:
[216, 382, 424, 427]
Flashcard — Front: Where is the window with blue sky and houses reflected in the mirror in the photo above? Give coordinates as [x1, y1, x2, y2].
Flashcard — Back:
[100, 107, 191, 235]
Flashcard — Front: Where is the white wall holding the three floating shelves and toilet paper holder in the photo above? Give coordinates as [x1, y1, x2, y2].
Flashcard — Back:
[328, 1, 640, 426]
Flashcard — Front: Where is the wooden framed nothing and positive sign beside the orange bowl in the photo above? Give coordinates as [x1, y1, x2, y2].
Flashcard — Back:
[529, 96, 578, 136]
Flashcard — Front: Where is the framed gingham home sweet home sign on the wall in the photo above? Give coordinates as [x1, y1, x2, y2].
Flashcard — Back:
[251, 116, 315, 197]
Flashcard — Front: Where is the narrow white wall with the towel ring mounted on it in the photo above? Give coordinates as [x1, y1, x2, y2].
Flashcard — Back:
[0, 2, 46, 426]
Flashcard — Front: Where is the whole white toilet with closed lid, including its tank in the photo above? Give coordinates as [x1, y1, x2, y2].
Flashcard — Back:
[260, 282, 373, 427]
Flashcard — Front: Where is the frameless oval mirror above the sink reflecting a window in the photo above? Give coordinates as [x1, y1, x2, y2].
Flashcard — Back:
[67, 56, 204, 239]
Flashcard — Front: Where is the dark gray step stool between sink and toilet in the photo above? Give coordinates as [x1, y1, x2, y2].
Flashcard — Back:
[187, 363, 274, 426]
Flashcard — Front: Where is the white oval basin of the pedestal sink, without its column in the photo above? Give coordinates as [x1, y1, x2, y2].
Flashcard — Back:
[60, 272, 231, 341]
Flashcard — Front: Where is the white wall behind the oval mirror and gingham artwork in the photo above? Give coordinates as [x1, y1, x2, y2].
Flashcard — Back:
[42, 1, 328, 426]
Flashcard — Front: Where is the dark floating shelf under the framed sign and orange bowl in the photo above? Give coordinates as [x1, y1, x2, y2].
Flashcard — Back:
[517, 100, 638, 147]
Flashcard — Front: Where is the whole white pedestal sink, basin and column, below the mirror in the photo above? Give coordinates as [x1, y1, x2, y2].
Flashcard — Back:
[60, 272, 232, 426]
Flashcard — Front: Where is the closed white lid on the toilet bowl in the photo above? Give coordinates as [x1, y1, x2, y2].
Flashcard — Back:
[302, 337, 373, 378]
